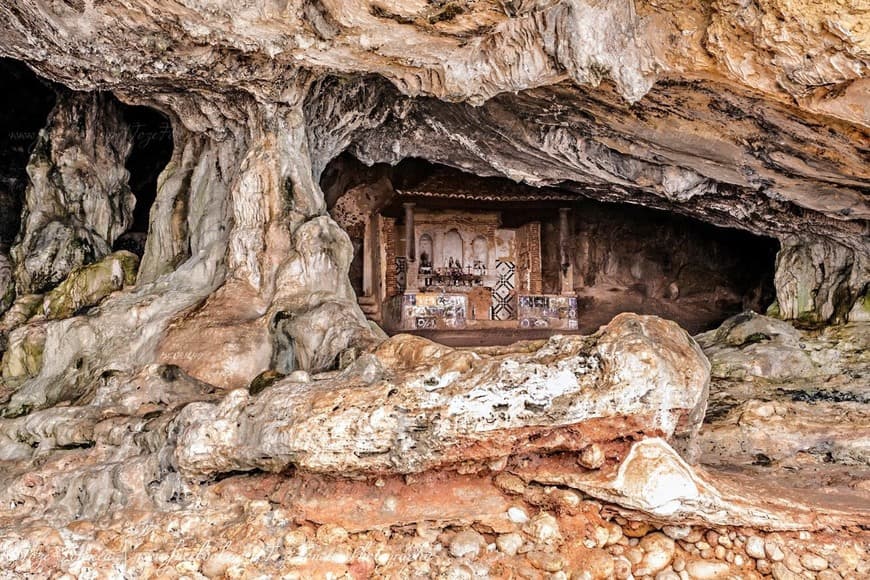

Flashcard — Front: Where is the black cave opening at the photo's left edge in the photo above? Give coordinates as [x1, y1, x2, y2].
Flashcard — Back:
[0, 58, 56, 252]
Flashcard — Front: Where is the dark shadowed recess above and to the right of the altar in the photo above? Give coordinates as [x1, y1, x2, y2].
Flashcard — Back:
[321, 153, 779, 336]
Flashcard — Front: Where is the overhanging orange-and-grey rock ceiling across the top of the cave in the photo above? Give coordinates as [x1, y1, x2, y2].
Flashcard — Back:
[0, 0, 870, 238]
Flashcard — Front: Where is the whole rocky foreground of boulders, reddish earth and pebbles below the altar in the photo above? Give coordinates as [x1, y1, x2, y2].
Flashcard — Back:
[0, 314, 870, 580]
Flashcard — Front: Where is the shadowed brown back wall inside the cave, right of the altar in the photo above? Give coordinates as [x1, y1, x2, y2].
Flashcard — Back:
[574, 204, 778, 306]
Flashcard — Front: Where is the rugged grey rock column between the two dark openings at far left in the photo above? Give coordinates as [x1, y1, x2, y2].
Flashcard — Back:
[12, 93, 134, 294]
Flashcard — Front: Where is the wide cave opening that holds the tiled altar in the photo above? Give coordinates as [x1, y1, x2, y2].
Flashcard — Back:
[322, 154, 779, 346]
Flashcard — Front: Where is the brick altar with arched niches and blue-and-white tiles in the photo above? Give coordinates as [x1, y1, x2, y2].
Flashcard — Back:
[385, 204, 541, 330]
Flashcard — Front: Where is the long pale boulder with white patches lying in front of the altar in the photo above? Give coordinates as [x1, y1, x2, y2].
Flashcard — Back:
[175, 315, 708, 477]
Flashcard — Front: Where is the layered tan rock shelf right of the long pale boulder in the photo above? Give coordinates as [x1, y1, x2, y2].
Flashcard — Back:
[698, 313, 870, 492]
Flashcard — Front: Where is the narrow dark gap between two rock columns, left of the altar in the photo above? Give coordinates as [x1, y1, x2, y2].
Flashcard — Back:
[114, 103, 173, 257]
